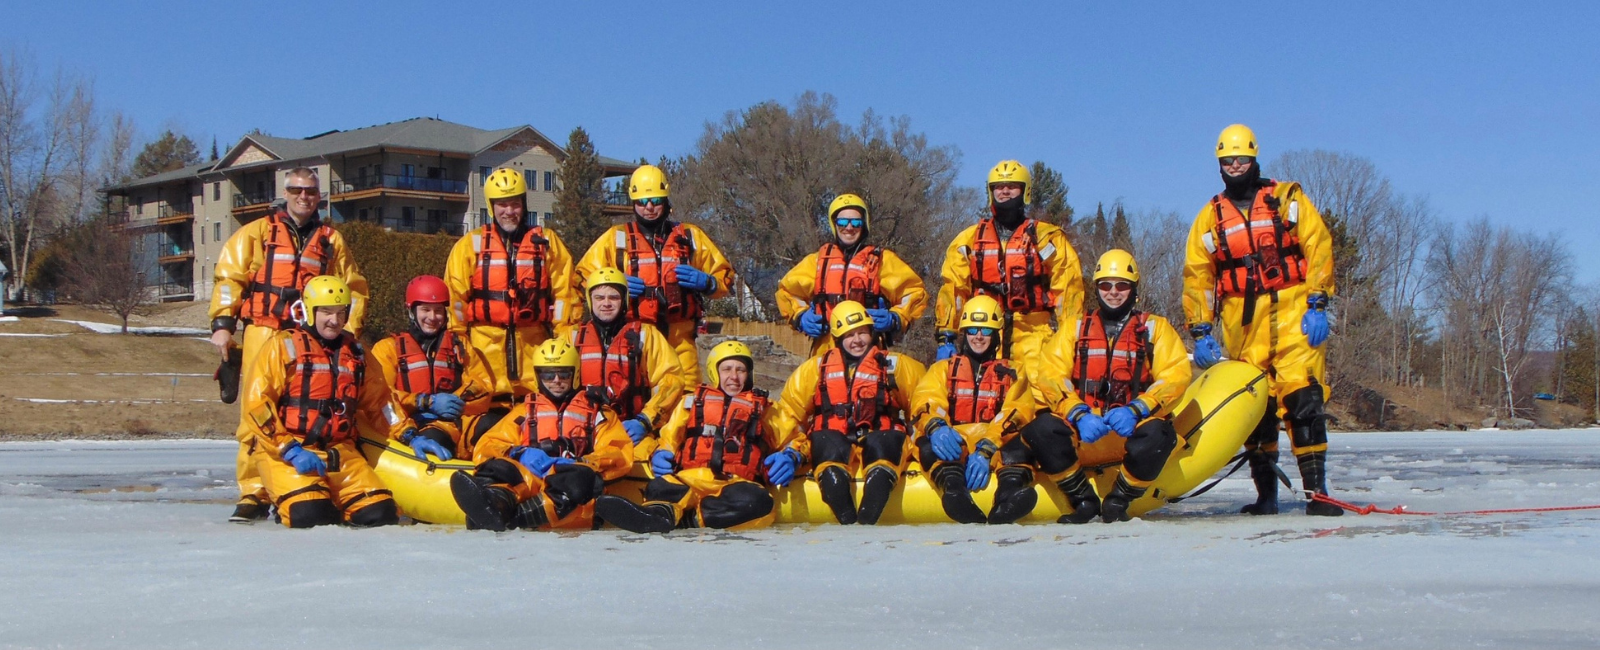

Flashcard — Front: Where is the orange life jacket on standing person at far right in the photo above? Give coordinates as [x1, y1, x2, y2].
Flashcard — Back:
[1202, 181, 1306, 296]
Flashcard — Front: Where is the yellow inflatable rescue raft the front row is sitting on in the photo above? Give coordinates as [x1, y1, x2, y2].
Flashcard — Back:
[362, 360, 1267, 525]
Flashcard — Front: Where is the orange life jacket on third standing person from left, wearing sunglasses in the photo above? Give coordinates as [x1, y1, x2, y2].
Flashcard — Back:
[614, 223, 701, 325]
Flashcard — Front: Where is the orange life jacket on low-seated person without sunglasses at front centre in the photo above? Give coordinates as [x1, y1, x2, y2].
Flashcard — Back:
[682, 384, 771, 480]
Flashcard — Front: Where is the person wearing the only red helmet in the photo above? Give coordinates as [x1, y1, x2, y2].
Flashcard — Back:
[371, 275, 472, 461]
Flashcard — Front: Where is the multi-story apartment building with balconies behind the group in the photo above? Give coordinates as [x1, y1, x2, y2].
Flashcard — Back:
[104, 117, 637, 301]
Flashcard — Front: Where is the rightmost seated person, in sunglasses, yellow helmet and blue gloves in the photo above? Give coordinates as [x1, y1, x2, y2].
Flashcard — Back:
[1024, 250, 1190, 524]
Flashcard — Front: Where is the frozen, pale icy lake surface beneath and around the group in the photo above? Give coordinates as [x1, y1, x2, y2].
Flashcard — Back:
[0, 429, 1600, 650]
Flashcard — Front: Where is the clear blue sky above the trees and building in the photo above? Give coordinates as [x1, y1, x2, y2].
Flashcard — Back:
[0, 2, 1600, 282]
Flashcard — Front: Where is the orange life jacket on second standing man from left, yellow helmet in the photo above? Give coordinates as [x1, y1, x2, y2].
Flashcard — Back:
[467, 224, 554, 327]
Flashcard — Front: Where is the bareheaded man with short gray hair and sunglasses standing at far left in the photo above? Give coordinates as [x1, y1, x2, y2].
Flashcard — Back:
[210, 167, 368, 524]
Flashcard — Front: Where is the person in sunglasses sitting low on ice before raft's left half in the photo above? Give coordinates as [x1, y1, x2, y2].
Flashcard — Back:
[450, 339, 634, 532]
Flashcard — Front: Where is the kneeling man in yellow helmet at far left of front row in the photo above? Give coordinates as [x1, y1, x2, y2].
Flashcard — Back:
[245, 275, 414, 528]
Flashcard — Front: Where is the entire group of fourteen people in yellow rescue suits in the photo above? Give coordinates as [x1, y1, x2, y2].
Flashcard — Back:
[211, 125, 1341, 532]
